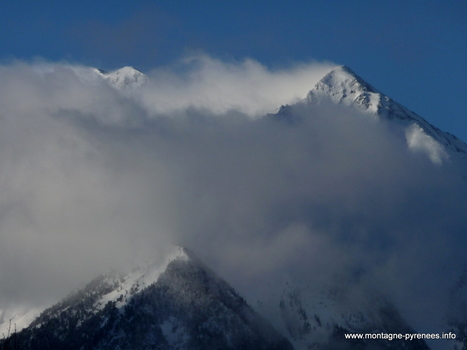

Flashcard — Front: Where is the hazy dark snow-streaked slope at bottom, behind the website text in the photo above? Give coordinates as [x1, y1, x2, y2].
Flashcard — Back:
[279, 281, 429, 350]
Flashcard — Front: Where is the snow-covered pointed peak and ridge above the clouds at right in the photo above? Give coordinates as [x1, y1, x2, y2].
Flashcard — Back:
[306, 66, 467, 165]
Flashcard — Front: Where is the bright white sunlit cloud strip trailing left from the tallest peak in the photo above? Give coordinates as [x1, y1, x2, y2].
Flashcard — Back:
[139, 55, 335, 117]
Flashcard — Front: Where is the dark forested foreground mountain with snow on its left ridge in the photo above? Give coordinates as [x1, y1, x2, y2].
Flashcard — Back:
[0, 248, 292, 350]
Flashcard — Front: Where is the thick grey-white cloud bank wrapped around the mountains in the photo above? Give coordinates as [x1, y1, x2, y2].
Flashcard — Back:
[0, 57, 467, 340]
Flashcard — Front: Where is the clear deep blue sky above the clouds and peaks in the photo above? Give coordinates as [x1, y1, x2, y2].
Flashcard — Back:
[0, 0, 467, 141]
